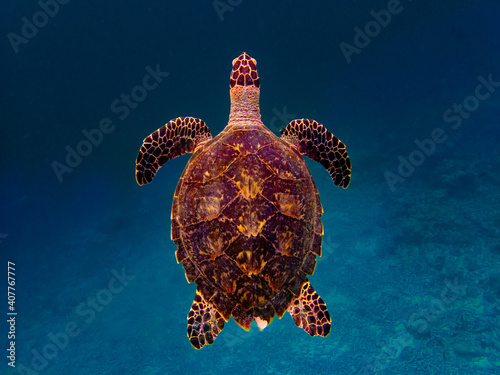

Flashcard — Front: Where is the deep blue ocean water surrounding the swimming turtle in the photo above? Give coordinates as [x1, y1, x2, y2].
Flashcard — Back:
[0, 0, 500, 375]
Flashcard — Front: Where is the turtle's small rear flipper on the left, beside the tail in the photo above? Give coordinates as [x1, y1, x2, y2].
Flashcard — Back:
[188, 291, 224, 349]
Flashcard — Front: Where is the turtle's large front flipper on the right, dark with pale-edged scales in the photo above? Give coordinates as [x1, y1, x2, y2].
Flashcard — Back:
[281, 119, 351, 188]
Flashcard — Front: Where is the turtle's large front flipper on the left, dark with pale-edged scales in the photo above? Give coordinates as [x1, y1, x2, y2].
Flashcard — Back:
[135, 117, 212, 185]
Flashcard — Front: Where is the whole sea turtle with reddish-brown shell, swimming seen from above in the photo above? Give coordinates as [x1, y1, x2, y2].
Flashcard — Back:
[136, 52, 351, 349]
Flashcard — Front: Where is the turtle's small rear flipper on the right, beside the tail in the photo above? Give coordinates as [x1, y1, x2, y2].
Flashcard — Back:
[288, 281, 331, 337]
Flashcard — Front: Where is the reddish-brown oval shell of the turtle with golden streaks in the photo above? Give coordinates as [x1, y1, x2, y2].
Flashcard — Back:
[172, 126, 323, 329]
